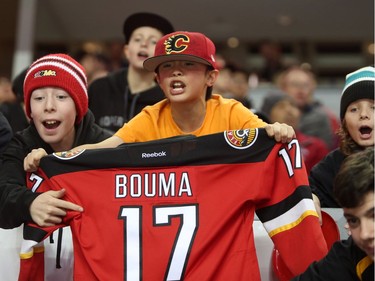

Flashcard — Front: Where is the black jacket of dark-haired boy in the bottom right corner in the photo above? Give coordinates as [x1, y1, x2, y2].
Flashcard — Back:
[292, 236, 374, 281]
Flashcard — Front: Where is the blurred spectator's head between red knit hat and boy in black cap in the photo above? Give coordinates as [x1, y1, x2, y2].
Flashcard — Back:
[75, 48, 109, 85]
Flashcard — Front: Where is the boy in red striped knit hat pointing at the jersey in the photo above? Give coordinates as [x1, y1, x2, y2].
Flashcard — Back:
[0, 54, 110, 280]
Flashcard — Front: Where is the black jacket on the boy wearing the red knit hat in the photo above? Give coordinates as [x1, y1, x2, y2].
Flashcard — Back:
[0, 111, 111, 228]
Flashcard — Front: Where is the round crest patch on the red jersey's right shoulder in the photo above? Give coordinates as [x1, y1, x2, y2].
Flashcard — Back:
[224, 129, 258, 149]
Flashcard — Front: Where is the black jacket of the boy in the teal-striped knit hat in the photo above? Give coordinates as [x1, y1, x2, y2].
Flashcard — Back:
[309, 148, 345, 208]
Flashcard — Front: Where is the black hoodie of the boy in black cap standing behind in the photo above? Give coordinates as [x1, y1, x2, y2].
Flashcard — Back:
[88, 68, 165, 132]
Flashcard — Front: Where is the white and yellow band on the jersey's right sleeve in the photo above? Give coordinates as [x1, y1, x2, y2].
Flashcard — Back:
[263, 199, 318, 237]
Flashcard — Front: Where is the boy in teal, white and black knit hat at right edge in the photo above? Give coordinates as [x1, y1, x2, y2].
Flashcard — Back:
[309, 66, 375, 218]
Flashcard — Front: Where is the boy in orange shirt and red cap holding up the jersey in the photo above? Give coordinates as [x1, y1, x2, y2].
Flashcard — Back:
[25, 31, 295, 152]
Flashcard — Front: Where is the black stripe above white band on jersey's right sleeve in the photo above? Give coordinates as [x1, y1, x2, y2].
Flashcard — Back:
[256, 185, 312, 222]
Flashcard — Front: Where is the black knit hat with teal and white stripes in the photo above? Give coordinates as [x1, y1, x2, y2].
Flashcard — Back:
[340, 66, 375, 120]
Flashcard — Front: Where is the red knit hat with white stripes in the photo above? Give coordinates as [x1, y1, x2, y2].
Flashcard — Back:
[23, 54, 88, 124]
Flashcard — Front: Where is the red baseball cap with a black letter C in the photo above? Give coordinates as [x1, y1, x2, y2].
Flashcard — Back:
[143, 31, 217, 71]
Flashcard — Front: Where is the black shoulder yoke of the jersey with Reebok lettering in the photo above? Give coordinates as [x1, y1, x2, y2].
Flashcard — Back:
[40, 129, 276, 178]
